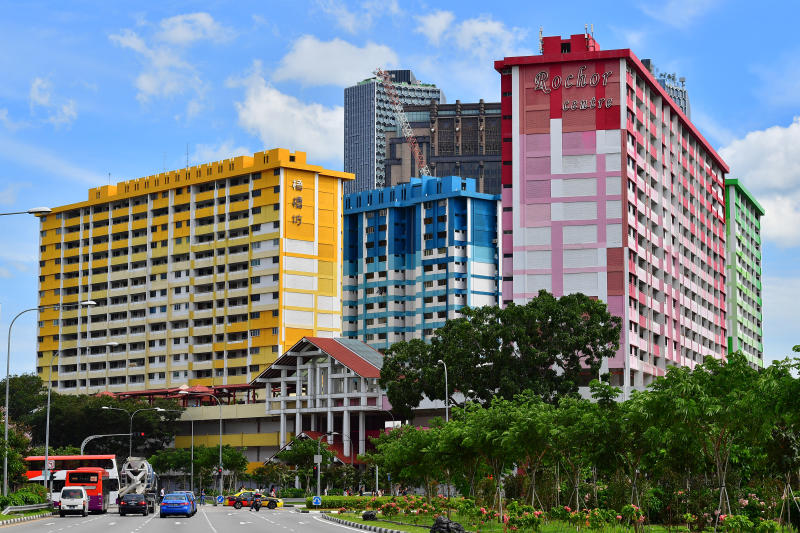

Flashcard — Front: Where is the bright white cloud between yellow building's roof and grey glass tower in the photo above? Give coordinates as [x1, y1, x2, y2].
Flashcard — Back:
[229, 62, 344, 165]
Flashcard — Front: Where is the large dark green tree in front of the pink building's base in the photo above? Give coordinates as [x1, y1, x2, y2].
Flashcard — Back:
[380, 291, 621, 418]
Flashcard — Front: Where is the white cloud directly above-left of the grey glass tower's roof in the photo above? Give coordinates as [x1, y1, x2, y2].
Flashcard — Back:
[272, 35, 398, 87]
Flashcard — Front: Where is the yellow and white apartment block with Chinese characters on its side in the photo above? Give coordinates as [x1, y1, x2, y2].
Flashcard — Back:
[37, 149, 352, 393]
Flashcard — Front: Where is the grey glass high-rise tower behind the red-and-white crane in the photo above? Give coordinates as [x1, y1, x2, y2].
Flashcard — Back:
[344, 70, 444, 193]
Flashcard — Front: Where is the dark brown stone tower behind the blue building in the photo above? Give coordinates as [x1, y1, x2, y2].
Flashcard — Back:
[384, 100, 500, 194]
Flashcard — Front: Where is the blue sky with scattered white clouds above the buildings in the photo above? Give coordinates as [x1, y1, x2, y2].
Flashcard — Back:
[0, 0, 800, 372]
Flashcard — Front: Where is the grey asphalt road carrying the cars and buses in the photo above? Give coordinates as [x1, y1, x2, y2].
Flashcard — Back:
[0, 505, 356, 533]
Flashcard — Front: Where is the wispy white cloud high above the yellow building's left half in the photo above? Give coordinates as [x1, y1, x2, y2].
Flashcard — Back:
[109, 13, 227, 119]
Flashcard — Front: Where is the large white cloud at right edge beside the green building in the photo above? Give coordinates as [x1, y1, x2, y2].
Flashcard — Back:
[719, 117, 800, 246]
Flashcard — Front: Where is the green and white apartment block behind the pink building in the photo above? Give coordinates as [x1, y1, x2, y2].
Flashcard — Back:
[725, 179, 765, 368]
